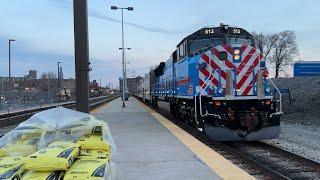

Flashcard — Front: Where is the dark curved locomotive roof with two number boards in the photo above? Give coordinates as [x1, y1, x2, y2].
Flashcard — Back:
[177, 24, 252, 47]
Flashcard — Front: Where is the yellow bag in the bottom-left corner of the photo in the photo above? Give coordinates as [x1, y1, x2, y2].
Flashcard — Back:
[0, 157, 25, 179]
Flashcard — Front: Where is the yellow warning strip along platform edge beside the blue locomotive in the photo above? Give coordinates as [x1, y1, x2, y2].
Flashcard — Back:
[141, 100, 255, 179]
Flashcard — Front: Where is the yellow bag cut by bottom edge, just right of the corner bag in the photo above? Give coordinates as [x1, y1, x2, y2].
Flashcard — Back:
[22, 171, 63, 180]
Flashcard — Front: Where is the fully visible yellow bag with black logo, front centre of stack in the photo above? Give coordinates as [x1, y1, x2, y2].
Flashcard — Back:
[25, 141, 79, 171]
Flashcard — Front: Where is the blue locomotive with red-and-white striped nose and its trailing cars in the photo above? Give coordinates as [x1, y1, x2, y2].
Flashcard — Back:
[134, 24, 282, 141]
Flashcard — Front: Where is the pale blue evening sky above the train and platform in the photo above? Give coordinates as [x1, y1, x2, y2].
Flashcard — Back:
[0, 0, 320, 86]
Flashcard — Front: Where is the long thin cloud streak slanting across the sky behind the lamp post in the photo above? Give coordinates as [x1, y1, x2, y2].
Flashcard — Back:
[49, 0, 182, 35]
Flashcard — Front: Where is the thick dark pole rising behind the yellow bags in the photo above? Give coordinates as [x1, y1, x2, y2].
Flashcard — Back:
[73, 0, 90, 113]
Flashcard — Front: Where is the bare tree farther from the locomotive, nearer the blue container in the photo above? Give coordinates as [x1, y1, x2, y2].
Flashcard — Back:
[270, 30, 298, 78]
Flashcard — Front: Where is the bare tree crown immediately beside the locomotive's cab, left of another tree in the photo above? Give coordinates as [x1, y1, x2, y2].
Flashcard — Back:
[252, 32, 278, 60]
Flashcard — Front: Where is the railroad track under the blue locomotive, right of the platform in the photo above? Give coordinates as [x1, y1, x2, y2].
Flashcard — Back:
[152, 102, 320, 180]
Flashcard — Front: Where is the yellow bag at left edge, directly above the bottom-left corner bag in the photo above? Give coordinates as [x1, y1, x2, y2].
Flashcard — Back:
[0, 138, 39, 157]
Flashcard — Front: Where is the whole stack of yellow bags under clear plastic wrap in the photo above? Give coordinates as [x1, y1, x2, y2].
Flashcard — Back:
[0, 106, 114, 180]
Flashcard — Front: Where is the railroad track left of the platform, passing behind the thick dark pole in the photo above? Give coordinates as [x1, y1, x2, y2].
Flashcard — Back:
[0, 95, 119, 127]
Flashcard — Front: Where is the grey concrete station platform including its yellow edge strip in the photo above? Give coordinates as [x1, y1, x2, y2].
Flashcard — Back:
[92, 97, 254, 180]
